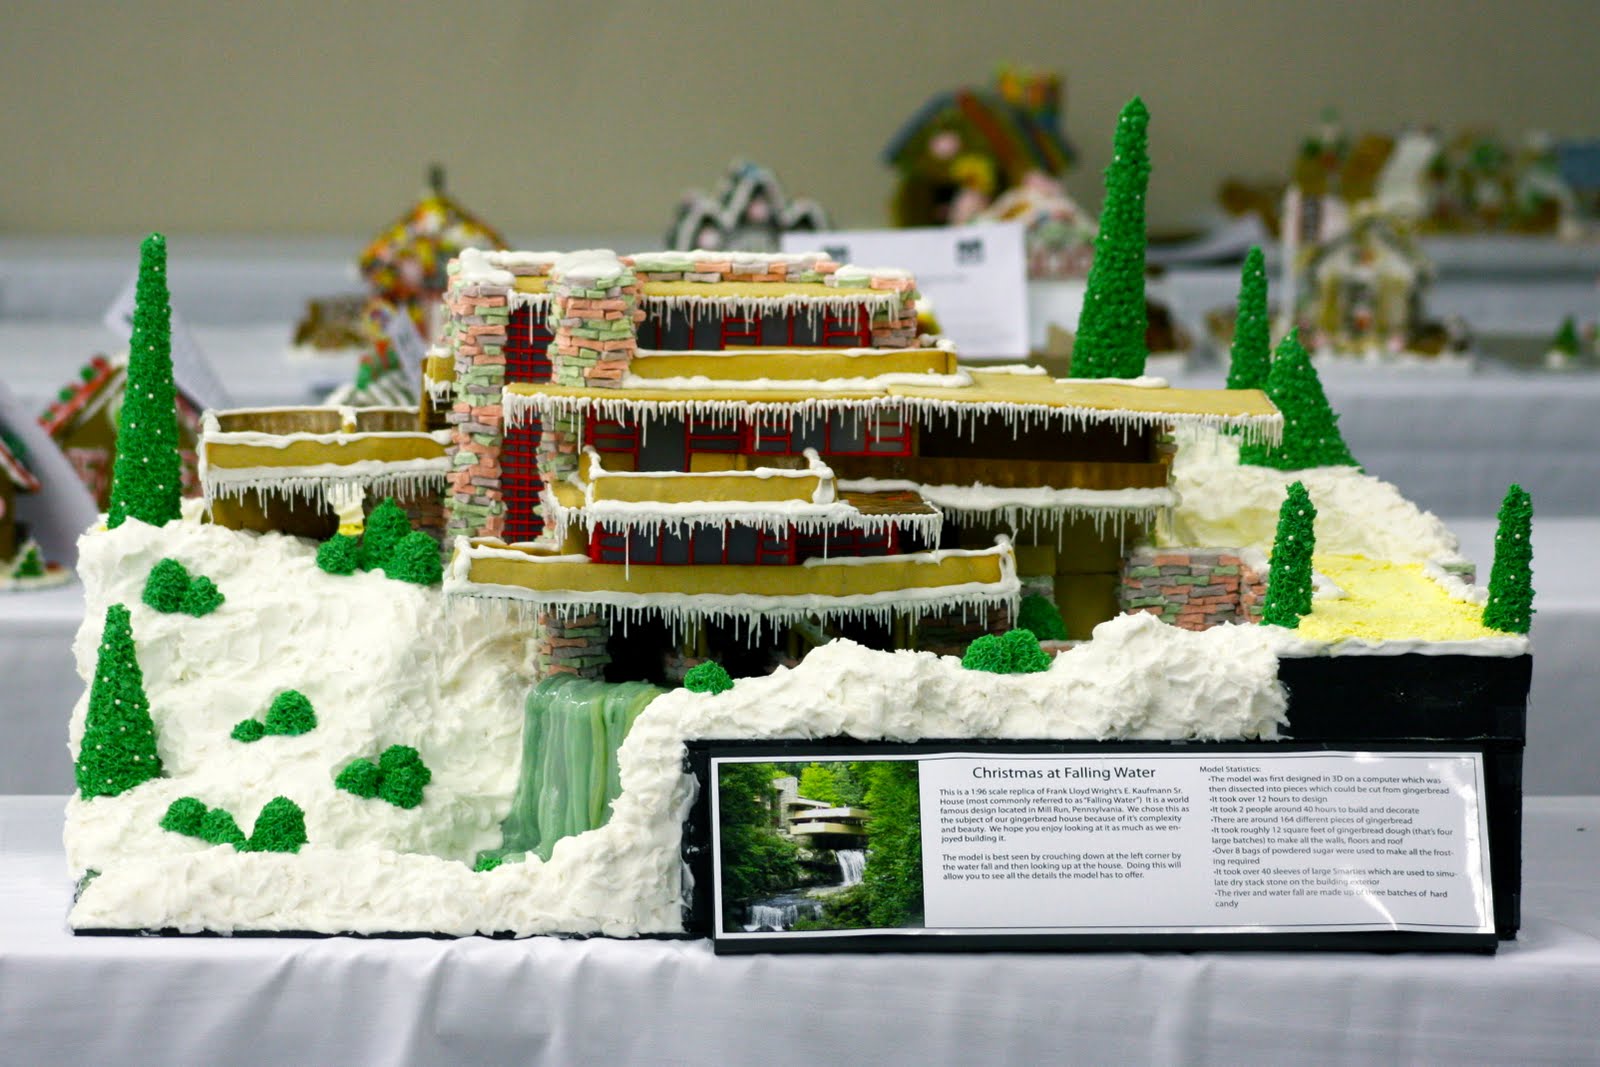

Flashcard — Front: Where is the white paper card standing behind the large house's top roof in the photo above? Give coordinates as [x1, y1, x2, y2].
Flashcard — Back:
[784, 222, 1027, 362]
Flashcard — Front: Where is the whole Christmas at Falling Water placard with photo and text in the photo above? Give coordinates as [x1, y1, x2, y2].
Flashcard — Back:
[710, 749, 1494, 947]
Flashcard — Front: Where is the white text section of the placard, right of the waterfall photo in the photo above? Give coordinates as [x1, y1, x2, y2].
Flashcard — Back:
[918, 752, 1494, 934]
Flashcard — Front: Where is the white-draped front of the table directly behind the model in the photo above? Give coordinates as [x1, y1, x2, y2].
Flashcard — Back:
[0, 517, 1600, 793]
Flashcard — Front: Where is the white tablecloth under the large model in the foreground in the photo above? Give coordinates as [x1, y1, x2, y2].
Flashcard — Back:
[0, 797, 1600, 1067]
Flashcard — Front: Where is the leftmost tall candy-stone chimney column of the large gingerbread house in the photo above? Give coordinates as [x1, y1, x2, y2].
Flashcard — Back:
[445, 262, 549, 542]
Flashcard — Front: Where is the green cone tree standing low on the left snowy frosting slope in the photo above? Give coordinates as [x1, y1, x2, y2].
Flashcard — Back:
[75, 605, 162, 800]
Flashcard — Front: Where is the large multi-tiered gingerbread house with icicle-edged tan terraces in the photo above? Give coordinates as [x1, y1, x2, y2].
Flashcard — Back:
[435, 251, 1282, 675]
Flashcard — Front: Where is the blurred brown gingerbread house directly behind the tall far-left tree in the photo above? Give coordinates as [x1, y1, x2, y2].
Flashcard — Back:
[38, 354, 200, 510]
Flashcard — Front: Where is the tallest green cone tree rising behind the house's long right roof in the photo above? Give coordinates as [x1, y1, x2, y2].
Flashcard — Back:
[1072, 96, 1150, 378]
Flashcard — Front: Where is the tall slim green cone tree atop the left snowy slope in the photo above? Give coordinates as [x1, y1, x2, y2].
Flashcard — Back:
[107, 234, 182, 526]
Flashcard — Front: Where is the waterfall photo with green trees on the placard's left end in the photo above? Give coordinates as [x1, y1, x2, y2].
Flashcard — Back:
[717, 758, 923, 933]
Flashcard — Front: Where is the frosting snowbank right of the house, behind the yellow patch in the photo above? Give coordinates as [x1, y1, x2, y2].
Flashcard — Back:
[1166, 429, 1461, 563]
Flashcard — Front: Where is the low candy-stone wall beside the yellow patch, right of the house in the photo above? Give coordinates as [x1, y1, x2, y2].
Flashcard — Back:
[1118, 549, 1267, 630]
